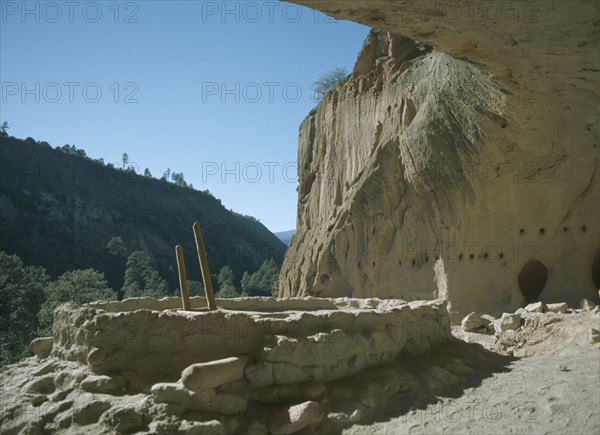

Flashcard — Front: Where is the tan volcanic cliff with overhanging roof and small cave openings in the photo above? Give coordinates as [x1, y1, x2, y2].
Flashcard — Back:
[280, 0, 600, 316]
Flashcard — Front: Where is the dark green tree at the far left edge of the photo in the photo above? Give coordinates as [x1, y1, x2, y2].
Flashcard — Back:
[0, 251, 50, 365]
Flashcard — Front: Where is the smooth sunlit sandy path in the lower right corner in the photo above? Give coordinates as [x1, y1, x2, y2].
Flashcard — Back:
[344, 314, 600, 434]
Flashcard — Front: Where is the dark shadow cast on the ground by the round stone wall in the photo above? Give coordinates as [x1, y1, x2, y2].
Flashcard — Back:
[312, 340, 517, 433]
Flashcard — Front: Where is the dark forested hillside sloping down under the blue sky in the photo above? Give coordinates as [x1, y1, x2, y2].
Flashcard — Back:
[0, 136, 286, 289]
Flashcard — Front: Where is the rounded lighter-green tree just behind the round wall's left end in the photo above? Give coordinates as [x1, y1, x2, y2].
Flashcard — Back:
[38, 269, 117, 336]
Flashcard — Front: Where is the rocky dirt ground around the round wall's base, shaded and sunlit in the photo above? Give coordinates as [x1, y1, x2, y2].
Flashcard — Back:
[0, 309, 600, 435]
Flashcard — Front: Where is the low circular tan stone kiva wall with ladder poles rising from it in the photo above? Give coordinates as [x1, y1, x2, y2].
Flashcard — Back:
[52, 298, 451, 388]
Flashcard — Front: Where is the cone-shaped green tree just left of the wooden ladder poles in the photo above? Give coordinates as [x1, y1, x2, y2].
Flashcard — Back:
[121, 251, 169, 299]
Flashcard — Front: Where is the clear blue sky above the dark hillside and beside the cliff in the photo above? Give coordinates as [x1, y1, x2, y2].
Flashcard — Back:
[0, 0, 369, 231]
